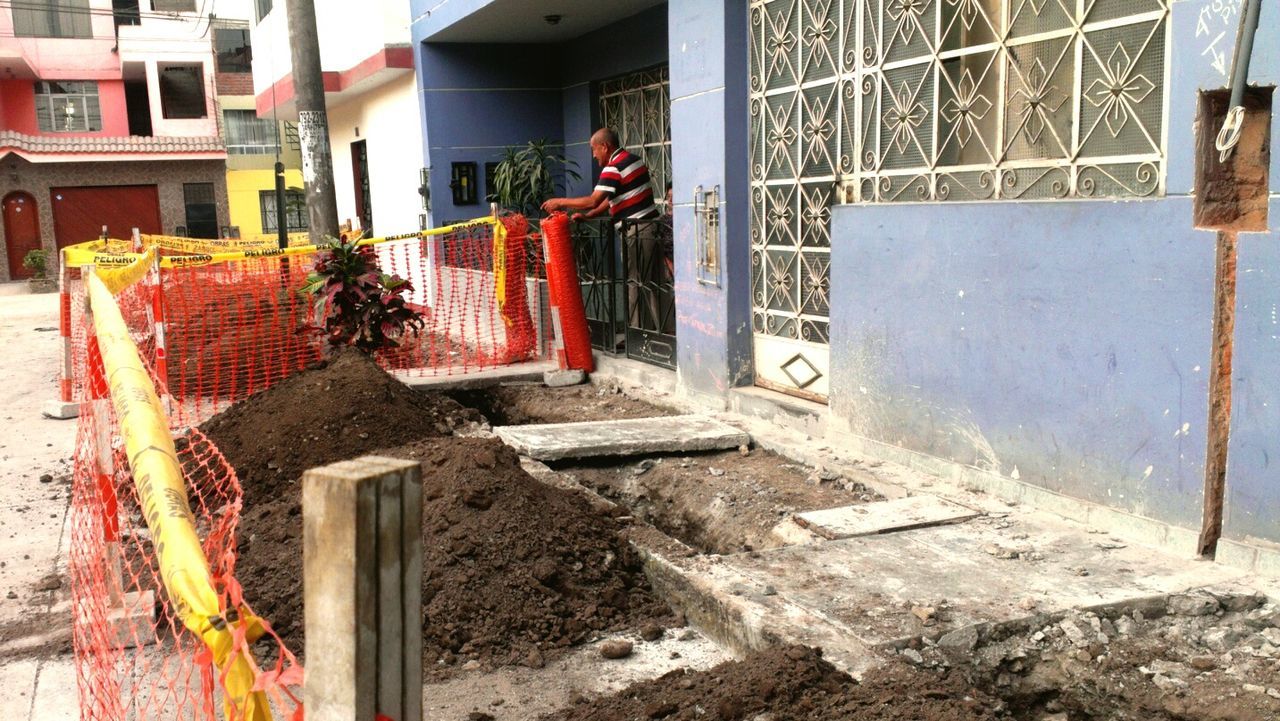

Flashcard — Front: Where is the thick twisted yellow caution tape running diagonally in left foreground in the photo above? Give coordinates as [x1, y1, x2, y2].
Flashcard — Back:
[86, 273, 271, 721]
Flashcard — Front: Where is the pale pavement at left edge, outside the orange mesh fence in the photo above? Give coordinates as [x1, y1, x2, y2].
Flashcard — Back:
[0, 289, 79, 721]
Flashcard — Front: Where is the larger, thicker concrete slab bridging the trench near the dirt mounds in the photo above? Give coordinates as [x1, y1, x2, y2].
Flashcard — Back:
[494, 415, 751, 461]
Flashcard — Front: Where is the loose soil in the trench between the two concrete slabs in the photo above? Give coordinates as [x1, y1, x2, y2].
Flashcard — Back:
[557, 448, 882, 555]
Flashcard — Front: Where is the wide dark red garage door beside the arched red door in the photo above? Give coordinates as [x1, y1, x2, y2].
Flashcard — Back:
[49, 186, 164, 247]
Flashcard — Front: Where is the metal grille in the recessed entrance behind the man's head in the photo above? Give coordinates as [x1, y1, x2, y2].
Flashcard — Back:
[600, 65, 671, 212]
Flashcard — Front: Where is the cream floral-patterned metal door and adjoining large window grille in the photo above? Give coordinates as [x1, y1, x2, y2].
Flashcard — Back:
[749, 0, 1170, 400]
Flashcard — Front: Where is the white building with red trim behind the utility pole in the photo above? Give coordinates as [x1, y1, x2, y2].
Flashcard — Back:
[251, 0, 424, 234]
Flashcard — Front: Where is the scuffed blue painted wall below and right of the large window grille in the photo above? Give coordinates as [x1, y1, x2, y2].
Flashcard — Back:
[831, 0, 1280, 542]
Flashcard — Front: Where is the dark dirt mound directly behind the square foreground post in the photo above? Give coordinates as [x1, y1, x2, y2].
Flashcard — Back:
[237, 438, 673, 679]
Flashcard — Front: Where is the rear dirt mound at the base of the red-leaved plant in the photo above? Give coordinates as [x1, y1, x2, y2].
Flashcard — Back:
[200, 350, 480, 508]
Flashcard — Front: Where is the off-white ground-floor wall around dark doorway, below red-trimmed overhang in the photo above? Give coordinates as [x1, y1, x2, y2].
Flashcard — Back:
[329, 73, 422, 236]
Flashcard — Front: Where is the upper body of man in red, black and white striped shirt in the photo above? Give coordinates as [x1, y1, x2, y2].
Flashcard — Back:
[543, 128, 658, 222]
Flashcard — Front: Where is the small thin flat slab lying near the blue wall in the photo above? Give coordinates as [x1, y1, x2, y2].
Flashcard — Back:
[795, 496, 979, 540]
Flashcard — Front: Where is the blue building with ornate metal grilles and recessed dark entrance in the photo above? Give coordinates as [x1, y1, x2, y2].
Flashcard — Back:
[412, 0, 1280, 571]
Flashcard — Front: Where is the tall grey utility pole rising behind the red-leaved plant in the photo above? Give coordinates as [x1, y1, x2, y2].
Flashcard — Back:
[285, 0, 338, 243]
